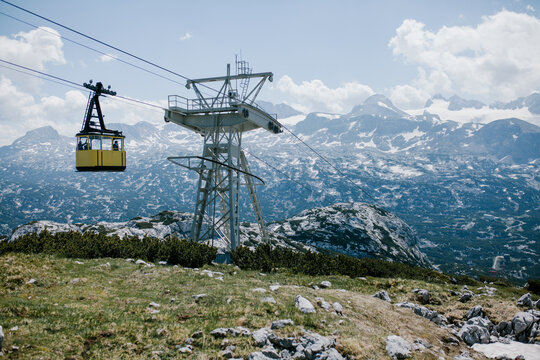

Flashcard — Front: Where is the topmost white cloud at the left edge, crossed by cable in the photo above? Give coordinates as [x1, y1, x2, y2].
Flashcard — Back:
[0, 27, 66, 91]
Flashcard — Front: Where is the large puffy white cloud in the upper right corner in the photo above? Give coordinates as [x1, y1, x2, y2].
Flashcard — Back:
[389, 10, 540, 102]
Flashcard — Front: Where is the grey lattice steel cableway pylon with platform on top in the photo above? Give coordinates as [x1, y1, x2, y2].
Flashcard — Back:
[165, 64, 282, 251]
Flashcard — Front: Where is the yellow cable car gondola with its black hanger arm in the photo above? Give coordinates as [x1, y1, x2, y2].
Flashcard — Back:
[76, 80, 126, 171]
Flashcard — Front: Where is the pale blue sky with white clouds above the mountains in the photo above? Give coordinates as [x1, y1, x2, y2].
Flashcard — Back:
[0, 0, 540, 145]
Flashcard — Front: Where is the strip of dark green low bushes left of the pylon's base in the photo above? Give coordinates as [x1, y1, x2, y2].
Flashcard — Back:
[0, 231, 217, 267]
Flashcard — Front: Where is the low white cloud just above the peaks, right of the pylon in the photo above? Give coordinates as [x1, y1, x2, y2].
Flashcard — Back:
[270, 75, 374, 114]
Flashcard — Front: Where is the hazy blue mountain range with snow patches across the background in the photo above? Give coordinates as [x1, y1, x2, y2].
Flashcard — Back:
[0, 93, 540, 277]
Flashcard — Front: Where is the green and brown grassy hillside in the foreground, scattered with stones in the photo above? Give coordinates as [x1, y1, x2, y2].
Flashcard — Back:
[0, 253, 523, 359]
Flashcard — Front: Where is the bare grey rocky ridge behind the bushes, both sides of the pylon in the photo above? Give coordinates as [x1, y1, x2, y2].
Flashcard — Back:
[10, 203, 431, 267]
